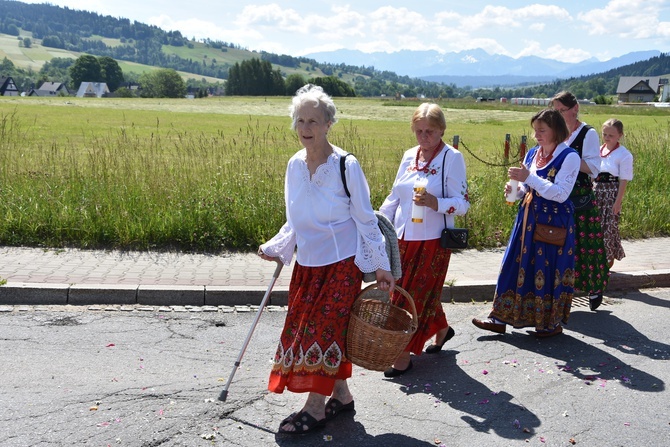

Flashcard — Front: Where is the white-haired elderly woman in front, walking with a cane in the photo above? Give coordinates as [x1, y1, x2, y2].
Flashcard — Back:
[258, 84, 395, 434]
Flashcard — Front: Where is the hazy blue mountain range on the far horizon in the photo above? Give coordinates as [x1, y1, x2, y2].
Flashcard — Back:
[305, 49, 661, 88]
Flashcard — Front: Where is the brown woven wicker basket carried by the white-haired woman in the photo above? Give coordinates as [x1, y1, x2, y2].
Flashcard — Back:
[346, 284, 419, 371]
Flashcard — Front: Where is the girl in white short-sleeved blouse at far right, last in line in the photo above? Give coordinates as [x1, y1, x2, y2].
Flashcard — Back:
[594, 118, 633, 267]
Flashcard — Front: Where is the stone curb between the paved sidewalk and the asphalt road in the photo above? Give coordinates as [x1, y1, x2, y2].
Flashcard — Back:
[0, 269, 670, 306]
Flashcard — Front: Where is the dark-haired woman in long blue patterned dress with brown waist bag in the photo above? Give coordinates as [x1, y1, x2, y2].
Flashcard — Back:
[472, 109, 580, 337]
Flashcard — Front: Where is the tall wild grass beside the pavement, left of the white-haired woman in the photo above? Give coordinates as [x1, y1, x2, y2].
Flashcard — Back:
[0, 114, 296, 251]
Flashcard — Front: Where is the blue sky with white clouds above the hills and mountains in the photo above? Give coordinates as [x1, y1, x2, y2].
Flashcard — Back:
[20, 0, 670, 62]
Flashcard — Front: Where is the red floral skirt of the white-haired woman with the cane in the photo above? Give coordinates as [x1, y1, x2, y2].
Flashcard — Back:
[268, 257, 363, 396]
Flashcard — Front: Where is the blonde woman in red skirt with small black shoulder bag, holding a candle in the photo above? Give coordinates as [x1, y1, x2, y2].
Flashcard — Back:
[379, 103, 470, 377]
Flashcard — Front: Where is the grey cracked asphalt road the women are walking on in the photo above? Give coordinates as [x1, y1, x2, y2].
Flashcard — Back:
[0, 289, 670, 447]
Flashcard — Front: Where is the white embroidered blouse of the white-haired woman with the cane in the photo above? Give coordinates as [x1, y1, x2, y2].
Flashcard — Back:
[261, 146, 391, 272]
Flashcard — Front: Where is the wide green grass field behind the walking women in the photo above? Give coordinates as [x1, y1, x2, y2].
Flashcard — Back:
[0, 97, 670, 252]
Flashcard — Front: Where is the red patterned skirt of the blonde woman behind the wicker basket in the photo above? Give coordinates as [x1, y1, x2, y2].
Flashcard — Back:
[391, 239, 451, 355]
